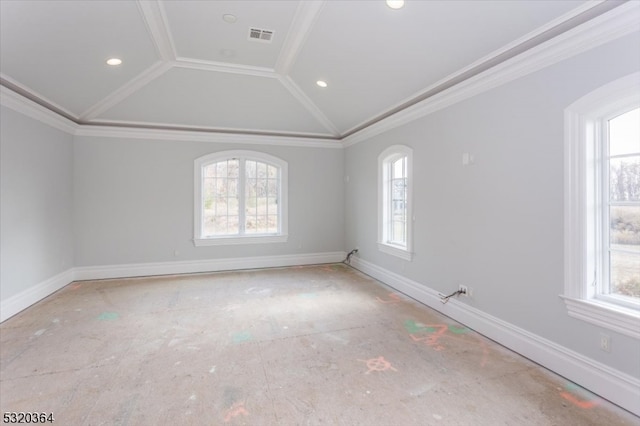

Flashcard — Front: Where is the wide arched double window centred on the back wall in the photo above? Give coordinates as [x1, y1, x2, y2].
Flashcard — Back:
[194, 151, 287, 245]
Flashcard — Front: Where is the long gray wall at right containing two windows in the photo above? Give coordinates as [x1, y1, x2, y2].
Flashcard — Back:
[345, 34, 640, 377]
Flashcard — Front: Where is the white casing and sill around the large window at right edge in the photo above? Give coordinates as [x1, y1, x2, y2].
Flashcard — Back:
[561, 72, 640, 339]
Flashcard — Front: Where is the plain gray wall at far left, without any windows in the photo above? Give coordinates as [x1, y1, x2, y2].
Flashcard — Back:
[0, 107, 74, 300]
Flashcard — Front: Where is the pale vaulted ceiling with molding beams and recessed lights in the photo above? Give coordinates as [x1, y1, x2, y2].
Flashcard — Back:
[0, 0, 615, 139]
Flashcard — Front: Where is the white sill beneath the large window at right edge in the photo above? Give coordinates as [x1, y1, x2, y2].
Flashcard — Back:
[560, 296, 640, 340]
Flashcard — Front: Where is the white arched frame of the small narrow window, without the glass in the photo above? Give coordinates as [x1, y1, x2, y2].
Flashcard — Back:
[378, 145, 413, 261]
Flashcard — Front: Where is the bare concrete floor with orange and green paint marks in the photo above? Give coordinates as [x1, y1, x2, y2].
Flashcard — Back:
[0, 264, 640, 426]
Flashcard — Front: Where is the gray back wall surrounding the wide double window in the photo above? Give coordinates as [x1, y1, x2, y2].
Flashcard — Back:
[74, 137, 344, 266]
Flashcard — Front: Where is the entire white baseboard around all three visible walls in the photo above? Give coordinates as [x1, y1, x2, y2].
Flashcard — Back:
[5, 252, 640, 416]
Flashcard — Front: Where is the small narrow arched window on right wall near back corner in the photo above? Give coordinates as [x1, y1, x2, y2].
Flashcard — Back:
[378, 145, 412, 260]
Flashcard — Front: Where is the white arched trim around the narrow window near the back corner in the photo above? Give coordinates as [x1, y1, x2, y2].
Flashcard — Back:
[378, 145, 413, 261]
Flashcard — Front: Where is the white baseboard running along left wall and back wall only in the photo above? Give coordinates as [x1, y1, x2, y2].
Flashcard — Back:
[0, 251, 346, 322]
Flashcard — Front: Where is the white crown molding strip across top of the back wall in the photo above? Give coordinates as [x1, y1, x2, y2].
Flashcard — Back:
[75, 125, 342, 149]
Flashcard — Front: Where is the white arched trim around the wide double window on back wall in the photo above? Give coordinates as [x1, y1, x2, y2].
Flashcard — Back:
[193, 150, 288, 247]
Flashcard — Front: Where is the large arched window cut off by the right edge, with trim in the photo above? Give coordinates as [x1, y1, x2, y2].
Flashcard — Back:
[564, 73, 640, 338]
